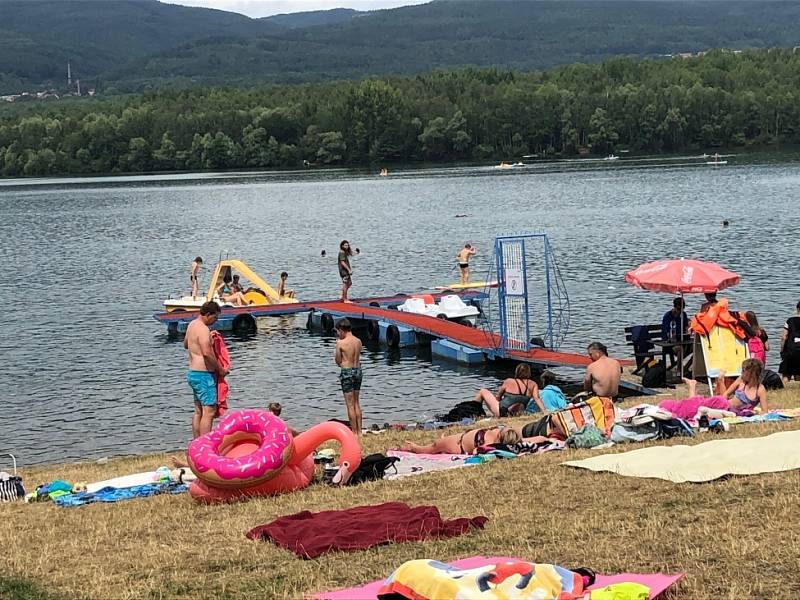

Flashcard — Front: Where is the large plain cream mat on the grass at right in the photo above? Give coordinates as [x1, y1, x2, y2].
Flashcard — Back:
[562, 431, 800, 483]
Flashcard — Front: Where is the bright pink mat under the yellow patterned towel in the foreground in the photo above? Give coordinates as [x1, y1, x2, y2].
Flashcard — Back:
[311, 556, 683, 600]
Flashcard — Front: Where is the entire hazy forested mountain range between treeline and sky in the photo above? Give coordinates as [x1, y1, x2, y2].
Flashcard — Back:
[0, 0, 800, 94]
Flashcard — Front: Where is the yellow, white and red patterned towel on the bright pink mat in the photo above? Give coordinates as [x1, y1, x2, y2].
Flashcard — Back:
[378, 559, 584, 600]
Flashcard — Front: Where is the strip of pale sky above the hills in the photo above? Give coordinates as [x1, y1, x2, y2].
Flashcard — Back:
[161, 0, 430, 17]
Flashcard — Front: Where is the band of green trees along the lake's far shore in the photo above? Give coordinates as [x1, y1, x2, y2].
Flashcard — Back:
[0, 50, 800, 176]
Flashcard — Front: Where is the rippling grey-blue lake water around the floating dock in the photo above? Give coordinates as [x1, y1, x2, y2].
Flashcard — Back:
[0, 159, 800, 468]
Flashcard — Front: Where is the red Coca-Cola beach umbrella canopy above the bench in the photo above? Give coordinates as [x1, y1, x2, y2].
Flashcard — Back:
[625, 258, 741, 294]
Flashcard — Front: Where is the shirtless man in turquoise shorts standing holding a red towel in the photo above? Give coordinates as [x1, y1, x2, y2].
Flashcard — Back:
[183, 302, 228, 438]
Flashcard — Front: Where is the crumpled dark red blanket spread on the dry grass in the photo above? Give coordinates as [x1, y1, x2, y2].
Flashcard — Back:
[247, 502, 489, 558]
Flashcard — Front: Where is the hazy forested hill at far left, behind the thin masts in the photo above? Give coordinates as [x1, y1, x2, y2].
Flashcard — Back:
[0, 0, 278, 94]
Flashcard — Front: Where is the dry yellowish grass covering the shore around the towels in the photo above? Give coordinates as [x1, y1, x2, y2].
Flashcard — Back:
[0, 388, 800, 599]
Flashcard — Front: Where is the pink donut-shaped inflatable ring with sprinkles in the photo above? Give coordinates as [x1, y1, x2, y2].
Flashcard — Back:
[186, 410, 292, 488]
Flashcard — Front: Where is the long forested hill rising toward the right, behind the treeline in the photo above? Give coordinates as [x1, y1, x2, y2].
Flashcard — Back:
[108, 0, 800, 90]
